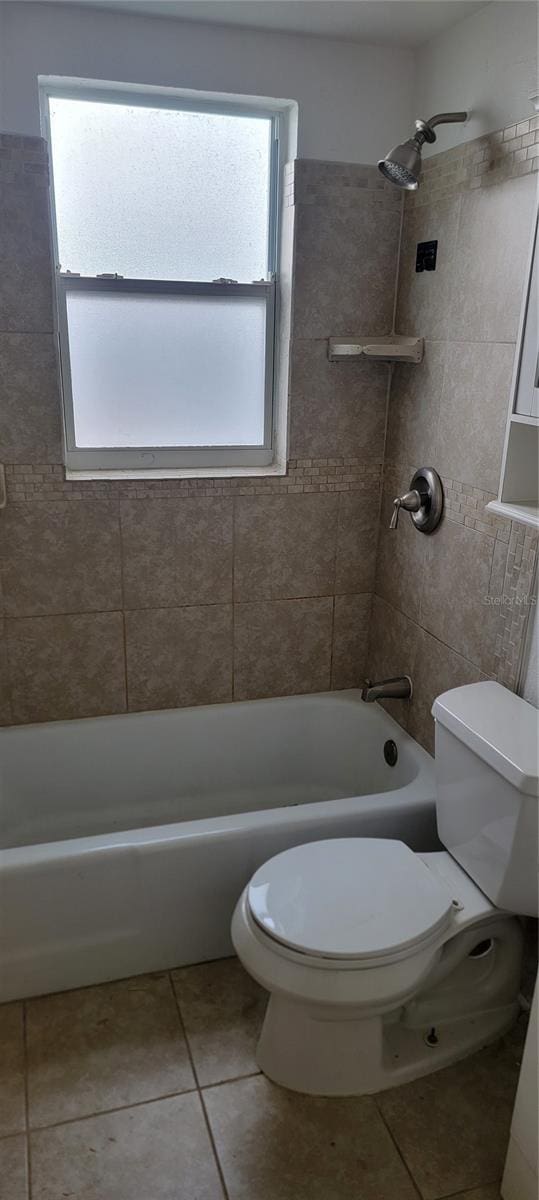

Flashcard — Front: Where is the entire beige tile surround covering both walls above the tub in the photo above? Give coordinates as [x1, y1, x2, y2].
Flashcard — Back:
[0, 126, 532, 734]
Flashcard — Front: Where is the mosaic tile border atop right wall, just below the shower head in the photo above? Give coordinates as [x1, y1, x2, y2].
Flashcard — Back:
[406, 116, 539, 208]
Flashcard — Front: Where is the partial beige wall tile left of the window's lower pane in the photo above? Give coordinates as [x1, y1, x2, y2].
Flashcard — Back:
[0, 333, 61, 463]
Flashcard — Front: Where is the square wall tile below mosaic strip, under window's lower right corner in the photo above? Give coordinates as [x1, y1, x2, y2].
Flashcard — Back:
[234, 493, 339, 600]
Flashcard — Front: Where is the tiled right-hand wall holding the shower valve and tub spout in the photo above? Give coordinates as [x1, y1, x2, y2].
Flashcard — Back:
[369, 118, 539, 750]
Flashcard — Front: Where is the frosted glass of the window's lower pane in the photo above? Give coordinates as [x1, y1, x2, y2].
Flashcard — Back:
[66, 290, 266, 448]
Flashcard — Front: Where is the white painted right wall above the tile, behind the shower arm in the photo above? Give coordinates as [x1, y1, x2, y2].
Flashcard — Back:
[415, 0, 538, 154]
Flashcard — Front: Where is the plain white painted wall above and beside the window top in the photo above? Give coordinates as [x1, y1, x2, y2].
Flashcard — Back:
[0, 2, 414, 162]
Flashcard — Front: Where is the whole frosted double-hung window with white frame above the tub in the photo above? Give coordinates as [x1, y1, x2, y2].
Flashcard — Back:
[42, 84, 279, 470]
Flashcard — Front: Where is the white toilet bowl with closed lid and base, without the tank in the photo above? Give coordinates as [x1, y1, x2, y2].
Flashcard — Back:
[232, 838, 522, 1096]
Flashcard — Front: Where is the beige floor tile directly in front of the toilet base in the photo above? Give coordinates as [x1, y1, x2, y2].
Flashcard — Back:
[204, 1075, 415, 1200]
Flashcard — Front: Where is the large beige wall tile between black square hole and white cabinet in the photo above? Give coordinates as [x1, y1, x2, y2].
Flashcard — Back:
[447, 176, 535, 342]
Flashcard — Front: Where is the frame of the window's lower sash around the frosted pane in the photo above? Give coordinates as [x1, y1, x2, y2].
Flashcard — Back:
[56, 272, 276, 470]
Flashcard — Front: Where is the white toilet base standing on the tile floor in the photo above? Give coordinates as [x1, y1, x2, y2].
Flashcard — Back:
[256, 995, 520, 1096]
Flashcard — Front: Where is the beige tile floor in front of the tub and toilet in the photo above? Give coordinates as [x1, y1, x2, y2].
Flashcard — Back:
[0, 959, 525, 1200]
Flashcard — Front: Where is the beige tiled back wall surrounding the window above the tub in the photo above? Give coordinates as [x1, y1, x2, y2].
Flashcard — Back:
[0, 136, 402, 724]
